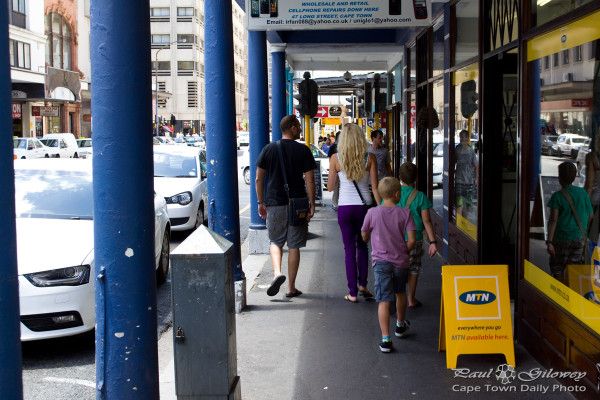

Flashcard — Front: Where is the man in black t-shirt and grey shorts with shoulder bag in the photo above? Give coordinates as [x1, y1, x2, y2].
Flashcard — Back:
[256, 115, 316, 297]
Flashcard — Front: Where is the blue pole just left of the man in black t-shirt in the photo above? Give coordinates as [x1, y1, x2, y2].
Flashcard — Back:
[248, 31, 268, 229]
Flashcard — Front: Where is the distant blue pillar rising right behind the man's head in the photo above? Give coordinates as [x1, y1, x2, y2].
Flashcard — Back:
[271, 45, 287, 142]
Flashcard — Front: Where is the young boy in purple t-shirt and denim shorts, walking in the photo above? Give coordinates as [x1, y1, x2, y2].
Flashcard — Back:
[361, 177, 417, 353]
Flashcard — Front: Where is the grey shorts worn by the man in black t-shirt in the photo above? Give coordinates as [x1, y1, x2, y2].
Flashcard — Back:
[267, 205, 308, 249]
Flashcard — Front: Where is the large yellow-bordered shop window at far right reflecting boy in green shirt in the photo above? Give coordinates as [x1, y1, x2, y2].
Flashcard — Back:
[523, 26, 600, 323]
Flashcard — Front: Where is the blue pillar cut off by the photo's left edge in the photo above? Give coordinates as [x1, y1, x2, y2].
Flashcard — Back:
[0, 6, 23, 400]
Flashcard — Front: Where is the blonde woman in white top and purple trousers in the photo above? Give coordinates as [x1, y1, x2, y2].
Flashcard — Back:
[327, 124, 381, 303]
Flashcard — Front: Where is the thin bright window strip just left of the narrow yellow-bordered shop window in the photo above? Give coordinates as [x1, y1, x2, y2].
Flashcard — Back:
[431, 79, 447, 215]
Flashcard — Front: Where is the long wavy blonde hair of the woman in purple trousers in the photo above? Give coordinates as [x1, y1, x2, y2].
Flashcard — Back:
[338, 124, 368, 181]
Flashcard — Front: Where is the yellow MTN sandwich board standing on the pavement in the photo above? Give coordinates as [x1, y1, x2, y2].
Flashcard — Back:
[439, 265, 515, 369]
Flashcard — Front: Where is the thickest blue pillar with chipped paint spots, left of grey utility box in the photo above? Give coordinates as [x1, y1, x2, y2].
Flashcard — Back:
[91, 0, 159, 400]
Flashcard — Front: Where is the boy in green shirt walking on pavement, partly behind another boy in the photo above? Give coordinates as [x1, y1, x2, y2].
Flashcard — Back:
[397, 162, 437, 308]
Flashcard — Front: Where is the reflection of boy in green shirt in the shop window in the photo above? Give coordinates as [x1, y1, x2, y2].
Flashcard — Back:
[546, 162, 594, 282]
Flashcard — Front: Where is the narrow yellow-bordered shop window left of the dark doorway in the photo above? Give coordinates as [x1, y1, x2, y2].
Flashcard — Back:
[449, 64, 479, 240]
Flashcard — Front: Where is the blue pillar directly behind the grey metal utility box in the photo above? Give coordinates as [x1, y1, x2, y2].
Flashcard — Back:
[204, 0, 244, 281]
